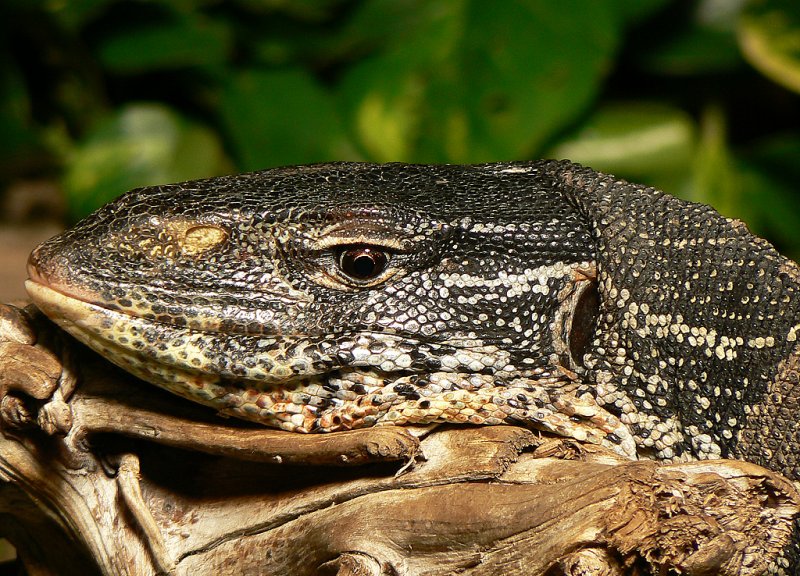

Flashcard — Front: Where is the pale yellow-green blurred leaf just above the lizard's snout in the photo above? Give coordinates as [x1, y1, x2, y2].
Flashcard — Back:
[64, 104, 230, 219]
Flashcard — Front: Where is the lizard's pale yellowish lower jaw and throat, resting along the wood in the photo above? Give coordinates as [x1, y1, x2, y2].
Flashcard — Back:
[26, 280, 635, 457]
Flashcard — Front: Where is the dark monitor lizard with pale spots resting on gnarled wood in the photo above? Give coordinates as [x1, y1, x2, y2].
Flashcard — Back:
[27, 161, 800, 564]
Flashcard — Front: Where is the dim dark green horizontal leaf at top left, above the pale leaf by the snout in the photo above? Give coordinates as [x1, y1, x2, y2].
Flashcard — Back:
[98, 13, 232, 74]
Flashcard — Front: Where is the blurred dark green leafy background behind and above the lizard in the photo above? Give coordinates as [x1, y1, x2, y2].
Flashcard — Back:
[0, 0, 800, 253]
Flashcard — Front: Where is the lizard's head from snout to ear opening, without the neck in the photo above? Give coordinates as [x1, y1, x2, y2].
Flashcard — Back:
[28, 163, 620, 438]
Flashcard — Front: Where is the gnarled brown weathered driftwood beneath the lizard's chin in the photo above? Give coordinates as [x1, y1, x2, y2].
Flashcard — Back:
[0, 307, 800, 576]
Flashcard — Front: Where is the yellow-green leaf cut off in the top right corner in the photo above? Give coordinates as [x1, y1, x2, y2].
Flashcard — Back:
[738, 0, 800, 92]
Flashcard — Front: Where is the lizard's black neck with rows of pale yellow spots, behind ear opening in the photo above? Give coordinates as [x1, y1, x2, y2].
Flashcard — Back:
[552, 163, 800, 477]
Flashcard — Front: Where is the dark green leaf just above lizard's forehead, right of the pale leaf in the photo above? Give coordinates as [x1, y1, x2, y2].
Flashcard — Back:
[220, 69, 356, 170]
